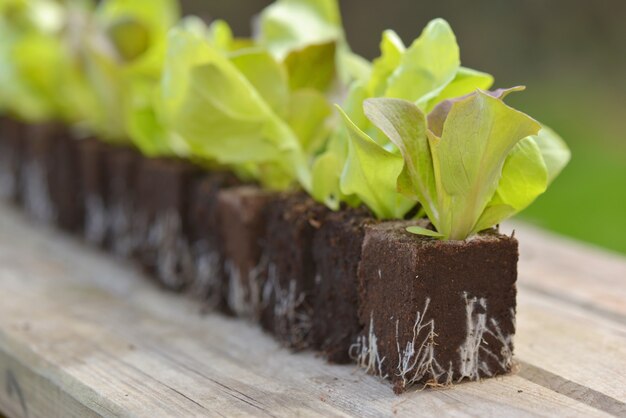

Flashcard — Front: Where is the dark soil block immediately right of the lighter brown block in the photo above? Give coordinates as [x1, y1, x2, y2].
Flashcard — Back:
[261, 193, 329, 350]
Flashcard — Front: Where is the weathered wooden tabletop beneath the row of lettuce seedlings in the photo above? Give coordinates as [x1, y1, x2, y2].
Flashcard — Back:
[0, 207, 626, 417]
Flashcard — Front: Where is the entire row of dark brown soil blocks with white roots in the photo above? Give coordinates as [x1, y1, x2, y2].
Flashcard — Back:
[0, 116, 518, 392]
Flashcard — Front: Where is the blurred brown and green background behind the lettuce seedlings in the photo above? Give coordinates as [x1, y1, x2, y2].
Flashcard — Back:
[183, 0, 626, 253]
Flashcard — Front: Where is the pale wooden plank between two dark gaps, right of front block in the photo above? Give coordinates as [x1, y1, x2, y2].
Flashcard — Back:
[516, 292, 626, 416]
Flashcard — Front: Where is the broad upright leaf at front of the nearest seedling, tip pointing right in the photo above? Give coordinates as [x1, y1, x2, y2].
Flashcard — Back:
[429, 91, 541, 239]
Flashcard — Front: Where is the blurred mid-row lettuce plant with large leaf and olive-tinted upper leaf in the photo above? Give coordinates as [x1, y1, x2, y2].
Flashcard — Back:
[162, 0, 352, 190]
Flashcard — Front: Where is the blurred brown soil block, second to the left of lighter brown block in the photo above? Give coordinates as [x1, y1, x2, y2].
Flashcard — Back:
[135, 158, 200, 290]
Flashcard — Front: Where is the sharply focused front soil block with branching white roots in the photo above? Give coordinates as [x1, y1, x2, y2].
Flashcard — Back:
[351, 222, 518, 393]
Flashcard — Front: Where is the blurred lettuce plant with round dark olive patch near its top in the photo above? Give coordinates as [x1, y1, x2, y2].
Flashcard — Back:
[83, 0, 180, 143]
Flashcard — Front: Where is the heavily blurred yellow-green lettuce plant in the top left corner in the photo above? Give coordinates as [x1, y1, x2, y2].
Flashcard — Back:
[0, 0, 93, 124]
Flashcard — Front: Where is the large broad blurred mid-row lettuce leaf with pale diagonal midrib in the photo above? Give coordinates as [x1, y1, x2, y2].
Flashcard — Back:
[163, 23, 312, 190]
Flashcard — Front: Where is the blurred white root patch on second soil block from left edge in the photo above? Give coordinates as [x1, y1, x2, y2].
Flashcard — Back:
[22, 161, 57, 223]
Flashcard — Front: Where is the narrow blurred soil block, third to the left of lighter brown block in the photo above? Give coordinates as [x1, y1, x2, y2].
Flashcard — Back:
[105, 146, 143, 258]
